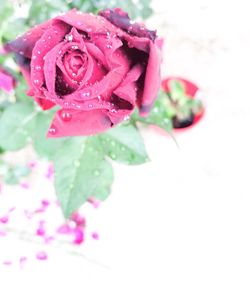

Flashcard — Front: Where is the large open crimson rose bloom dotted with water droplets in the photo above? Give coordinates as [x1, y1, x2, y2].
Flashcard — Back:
[5, 9, 161, 137]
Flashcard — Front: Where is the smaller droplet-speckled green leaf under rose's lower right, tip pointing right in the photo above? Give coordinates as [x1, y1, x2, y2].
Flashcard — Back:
[99, 123, 148, 165]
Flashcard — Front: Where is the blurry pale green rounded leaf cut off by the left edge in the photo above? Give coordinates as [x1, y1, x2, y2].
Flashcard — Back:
[0, 103, 37, 150]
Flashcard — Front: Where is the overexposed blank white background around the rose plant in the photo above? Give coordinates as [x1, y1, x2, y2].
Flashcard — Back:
[0, 0, 250, 294]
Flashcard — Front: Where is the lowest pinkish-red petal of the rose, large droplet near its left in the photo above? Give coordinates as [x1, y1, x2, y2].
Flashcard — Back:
[47, 110, 112, 138]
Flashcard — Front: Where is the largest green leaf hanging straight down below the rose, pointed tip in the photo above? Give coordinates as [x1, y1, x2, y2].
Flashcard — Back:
[54, 137, 113, 217]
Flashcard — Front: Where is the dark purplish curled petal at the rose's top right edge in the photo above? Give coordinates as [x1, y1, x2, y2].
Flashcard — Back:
[99, 8, 156, 42]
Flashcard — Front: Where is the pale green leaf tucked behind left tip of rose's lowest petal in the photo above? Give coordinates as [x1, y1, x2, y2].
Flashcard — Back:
[33, 110, 66, 159]
